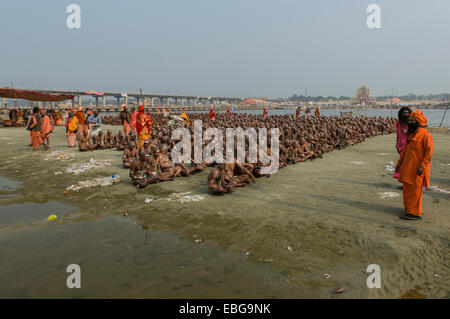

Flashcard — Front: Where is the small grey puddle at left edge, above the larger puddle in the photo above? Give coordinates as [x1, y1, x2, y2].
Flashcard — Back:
[0, 202, 75, 225]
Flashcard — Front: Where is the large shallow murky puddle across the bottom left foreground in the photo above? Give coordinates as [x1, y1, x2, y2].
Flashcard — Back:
[0, 216, 314, 298]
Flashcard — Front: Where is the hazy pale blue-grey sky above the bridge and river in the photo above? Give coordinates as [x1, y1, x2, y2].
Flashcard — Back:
[0, 0, 450, 97]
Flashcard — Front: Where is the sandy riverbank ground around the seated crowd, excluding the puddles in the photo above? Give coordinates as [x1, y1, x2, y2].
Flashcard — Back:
[0, 126, 450, 298]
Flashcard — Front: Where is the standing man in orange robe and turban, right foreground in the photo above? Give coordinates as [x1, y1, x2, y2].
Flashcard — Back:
[395, 110, 433, 220]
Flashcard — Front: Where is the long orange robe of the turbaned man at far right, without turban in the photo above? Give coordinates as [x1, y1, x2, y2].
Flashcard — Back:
[397, 127, 433, 216]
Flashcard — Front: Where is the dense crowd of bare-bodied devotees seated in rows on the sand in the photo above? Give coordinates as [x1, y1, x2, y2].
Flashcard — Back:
[114, 114, 395, 194]
